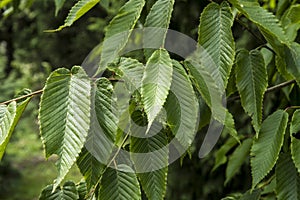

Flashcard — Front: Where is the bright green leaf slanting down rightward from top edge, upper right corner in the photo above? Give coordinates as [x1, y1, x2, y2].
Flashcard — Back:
[229, 0, 288, 43]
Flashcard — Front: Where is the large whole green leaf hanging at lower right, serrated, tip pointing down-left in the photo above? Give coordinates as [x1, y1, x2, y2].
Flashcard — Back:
[251, 110, 288, 189]
